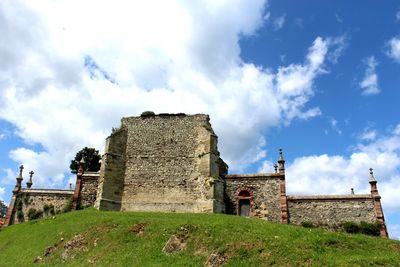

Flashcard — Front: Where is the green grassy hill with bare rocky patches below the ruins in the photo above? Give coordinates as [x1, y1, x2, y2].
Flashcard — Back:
[0, 209, 400, 266]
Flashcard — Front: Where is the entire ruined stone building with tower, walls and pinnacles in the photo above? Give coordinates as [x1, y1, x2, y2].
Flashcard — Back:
[6, 112, 388, 237]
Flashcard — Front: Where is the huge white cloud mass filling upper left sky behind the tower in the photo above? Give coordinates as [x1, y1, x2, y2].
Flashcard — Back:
[0, 1, 340, 187]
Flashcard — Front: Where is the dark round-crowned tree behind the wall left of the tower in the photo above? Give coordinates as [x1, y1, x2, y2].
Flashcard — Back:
[69, 147, 101, 173]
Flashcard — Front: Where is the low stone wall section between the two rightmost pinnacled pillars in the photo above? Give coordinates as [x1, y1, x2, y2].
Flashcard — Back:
[287, 194, 376, 229]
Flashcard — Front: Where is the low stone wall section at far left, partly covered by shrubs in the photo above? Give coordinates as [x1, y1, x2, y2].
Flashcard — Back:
[10, 188, 74, 224]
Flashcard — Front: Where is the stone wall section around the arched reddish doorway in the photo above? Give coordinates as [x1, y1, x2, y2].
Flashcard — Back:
[225, 173, 281, 222]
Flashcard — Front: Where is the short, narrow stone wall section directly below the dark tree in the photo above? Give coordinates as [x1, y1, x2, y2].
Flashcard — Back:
[79, 172, 99, 207]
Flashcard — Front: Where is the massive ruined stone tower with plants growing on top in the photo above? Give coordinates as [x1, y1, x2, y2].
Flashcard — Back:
[95, 112, 227, 212]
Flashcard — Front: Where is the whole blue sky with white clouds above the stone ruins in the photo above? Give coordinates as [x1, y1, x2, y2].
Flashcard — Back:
[0, 0, 400, 239]
